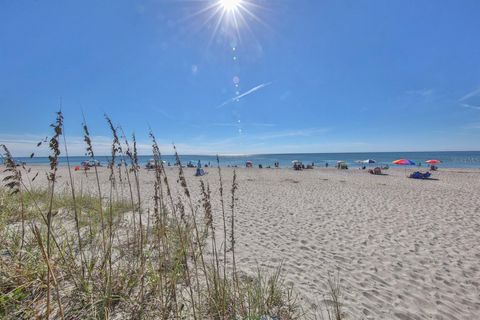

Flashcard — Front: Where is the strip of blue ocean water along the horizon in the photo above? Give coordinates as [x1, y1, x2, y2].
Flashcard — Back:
[5, 151, 480, 168]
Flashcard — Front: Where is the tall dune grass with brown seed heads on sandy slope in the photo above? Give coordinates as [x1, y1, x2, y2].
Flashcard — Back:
[0, 112, 303, 320]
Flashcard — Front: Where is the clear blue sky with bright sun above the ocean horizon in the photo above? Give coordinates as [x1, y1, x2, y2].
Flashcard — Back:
[0, 0, 480, 156]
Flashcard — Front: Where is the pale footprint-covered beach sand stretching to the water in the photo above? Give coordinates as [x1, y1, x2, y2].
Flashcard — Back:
[5, 166, 480, 319]
